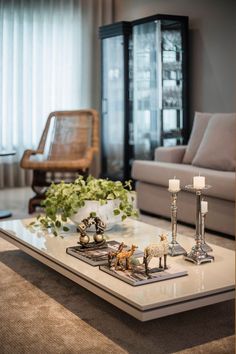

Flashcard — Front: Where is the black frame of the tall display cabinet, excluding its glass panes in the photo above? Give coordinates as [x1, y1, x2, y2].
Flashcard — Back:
[99, 14, 190, 181]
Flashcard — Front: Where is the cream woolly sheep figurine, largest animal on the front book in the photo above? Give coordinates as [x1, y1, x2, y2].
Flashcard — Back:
[143, 234, 169, 275]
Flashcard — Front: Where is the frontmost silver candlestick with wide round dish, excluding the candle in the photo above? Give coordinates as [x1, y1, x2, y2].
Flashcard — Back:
[185, 185, 214, 264]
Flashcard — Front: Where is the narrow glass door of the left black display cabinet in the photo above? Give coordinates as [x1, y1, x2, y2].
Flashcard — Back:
[102, 35, 124, 179]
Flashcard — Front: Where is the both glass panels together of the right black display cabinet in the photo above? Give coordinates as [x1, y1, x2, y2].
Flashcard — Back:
[130, 20, 186, 160]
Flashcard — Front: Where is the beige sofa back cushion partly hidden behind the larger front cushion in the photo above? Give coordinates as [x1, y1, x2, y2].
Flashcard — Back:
[183, 112, 212, 163]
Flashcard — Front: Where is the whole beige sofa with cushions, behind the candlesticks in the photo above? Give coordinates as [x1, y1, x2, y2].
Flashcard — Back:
[132, 113, 236, 236]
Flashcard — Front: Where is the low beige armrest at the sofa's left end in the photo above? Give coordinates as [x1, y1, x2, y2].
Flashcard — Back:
[154, 145, 187, 163]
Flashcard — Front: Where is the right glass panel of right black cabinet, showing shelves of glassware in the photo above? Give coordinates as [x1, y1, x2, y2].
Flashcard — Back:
[161, 21, 183, 146]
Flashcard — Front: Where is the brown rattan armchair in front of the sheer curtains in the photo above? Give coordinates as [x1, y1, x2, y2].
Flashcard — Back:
[20, 109, 99, 213]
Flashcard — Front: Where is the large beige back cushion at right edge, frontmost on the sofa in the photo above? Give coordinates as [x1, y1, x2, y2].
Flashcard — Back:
[192, 113, 236, 171]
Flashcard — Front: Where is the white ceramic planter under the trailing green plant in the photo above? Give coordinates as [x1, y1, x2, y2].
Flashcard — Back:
[70, 199, 121, 231]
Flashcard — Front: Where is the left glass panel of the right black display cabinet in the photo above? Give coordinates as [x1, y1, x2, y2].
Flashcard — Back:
[131, 21, 162, 160]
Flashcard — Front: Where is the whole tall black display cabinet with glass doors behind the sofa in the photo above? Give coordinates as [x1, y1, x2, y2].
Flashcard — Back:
[99, 15, 189, 180]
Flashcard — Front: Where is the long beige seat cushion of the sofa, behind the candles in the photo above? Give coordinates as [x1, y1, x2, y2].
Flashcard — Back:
[132, 160, 235, 201]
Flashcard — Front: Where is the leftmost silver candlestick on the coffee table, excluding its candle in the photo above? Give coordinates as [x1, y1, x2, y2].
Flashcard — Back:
[168, 190, 187, 257]
